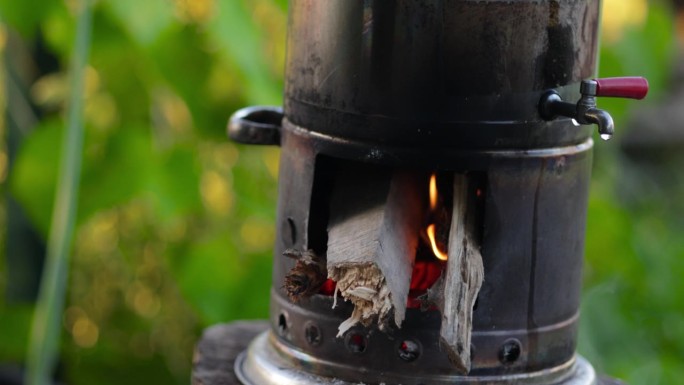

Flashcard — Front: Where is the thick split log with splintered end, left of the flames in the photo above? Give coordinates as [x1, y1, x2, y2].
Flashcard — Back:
[327, 169, 425, 336]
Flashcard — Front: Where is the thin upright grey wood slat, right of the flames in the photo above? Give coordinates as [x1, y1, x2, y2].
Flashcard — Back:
[430, 174, 484, 374]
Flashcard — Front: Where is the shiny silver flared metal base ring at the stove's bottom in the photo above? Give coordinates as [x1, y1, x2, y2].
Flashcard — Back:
[235, 331, 610, 385]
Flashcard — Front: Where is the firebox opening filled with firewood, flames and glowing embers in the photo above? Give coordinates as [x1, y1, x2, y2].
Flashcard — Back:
[285, 157, 485, 373]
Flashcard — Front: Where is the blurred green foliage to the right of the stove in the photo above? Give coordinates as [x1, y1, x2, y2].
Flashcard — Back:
[579, 0, 684, 385]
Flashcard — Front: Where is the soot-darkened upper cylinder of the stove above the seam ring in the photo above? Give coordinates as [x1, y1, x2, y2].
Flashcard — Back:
[285, 0, 600, 148]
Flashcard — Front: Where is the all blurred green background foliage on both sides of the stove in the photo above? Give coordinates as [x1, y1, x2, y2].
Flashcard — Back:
[0, 0, 684, 385]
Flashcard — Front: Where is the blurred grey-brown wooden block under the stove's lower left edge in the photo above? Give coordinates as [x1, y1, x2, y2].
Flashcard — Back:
[192, 320, 268, 385]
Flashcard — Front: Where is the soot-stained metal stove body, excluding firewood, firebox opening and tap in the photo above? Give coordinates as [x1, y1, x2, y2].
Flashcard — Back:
[230, 0, 600, 385]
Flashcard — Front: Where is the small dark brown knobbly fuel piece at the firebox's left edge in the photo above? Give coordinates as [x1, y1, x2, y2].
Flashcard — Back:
[283, 249, 327, 303]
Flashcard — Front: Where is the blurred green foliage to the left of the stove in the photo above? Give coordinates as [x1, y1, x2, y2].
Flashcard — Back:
[0, 0, 286, 384]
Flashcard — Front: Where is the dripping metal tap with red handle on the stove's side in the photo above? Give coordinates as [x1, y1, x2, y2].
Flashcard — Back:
[539, 77, 648, 140]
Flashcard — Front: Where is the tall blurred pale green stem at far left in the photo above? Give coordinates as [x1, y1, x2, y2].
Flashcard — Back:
[26, 0, 92, 385]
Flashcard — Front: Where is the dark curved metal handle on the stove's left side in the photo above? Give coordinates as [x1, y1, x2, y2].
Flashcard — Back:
[227, 106, 283, 145]
